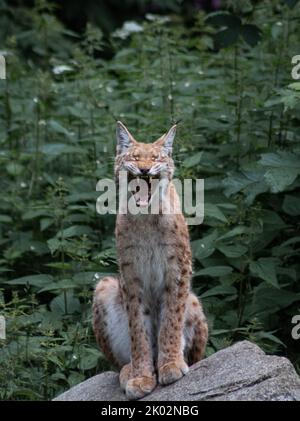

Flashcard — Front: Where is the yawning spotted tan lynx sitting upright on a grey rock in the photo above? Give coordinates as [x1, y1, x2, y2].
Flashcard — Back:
[93, 122, 208, 399]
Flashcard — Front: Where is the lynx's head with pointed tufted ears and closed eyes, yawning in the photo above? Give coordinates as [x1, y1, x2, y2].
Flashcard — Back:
[115, 121, 176, 206]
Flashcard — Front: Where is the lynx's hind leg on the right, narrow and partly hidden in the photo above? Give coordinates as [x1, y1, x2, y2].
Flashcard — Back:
[183, 293, 208, 365]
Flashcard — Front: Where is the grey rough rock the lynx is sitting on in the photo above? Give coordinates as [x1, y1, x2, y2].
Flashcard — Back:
[54, 341, 300, 401]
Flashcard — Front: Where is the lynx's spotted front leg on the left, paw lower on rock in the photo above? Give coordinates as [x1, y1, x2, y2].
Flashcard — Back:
[122, 274, 156, 399]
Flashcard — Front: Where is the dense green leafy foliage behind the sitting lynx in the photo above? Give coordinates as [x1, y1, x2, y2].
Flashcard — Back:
[0, 1, 300, 399]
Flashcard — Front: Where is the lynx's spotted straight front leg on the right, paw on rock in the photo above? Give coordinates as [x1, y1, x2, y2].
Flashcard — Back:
[157, 256, 191, 385]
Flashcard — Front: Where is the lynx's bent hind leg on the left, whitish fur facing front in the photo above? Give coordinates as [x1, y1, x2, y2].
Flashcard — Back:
[93, 276, 130, 368]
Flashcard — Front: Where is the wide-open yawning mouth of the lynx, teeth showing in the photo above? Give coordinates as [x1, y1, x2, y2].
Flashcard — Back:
[128, 173, 160, 207]
